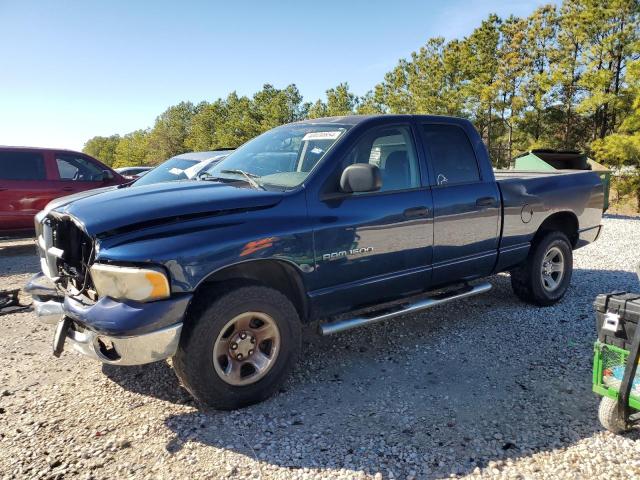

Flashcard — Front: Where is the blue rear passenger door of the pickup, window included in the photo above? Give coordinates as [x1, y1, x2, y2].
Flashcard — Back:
[420, 123, 500, 286]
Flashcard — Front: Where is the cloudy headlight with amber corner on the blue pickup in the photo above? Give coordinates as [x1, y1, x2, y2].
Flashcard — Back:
[91, 263, 171, 302]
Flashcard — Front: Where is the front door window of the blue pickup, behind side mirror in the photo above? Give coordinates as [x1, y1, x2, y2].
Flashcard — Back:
[343, 127, 420, 192]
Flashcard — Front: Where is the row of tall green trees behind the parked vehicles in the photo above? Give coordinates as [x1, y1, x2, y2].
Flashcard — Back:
[84, 0, 640, 204]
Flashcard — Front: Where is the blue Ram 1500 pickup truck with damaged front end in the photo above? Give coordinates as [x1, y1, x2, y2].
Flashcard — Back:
[27, 115, 604, 409]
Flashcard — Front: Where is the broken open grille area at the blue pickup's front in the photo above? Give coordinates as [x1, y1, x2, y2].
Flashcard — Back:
[36, 214, 95, 297]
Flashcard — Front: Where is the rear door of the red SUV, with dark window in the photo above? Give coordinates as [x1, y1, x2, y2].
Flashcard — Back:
[0, 150, 55, 231]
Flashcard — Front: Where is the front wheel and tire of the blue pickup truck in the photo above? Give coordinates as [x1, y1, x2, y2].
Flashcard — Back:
[173, 284, 301, 410]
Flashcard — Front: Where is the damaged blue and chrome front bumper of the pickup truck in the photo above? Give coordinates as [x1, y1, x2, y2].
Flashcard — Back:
[25, 273, 191, 365]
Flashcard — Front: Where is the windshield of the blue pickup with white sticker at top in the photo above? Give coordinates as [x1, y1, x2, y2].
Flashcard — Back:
[200, 124, 347, 188]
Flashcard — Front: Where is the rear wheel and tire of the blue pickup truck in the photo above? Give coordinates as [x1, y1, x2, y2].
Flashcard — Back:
[511, 232, 573, 307]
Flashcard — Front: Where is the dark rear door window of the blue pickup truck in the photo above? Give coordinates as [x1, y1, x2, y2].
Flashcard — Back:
[422, 125, 480, 185]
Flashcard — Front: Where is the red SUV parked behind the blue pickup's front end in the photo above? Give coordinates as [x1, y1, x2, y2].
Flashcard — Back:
[0, 147, 130, 233]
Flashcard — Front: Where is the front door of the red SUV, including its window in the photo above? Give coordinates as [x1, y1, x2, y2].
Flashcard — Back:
[55, 153, 104, 196]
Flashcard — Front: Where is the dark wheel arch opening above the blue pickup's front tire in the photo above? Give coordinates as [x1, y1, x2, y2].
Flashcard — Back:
[194, 259, 309, 322]
